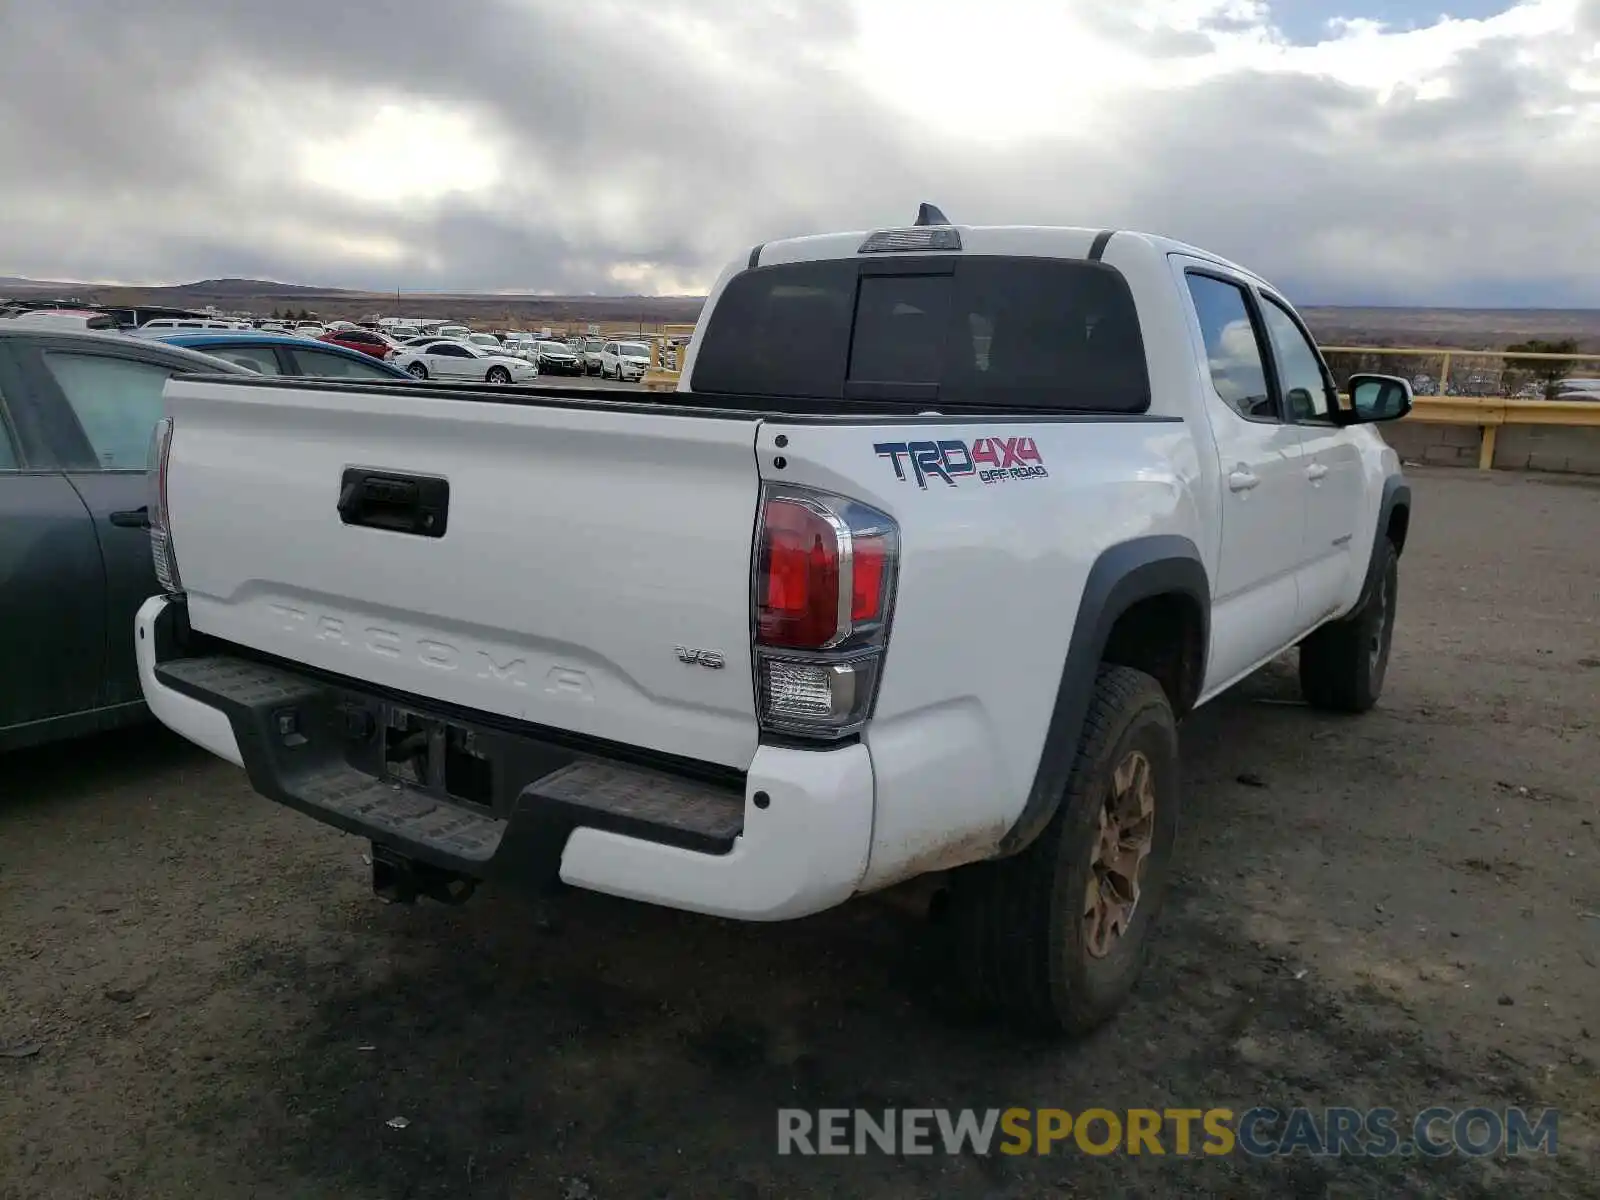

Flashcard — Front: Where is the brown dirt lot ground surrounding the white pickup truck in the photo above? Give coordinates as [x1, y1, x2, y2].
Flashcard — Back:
[0, 472, 1600, 1200]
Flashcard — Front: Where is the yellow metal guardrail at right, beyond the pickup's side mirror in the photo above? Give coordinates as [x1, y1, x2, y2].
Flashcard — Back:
[1322, 346, 1600, 470]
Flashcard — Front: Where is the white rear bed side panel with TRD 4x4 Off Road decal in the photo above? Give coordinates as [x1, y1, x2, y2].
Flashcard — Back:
[757, 416, 1200, 890]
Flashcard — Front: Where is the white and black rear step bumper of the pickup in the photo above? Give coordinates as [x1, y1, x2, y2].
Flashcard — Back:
[134, 597, 874, 920]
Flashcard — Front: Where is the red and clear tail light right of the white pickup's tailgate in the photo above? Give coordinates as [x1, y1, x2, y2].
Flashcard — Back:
[752, 485, 899, 739]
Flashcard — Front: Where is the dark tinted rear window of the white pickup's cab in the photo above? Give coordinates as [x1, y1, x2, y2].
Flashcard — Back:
[691, 256, 1150, 413]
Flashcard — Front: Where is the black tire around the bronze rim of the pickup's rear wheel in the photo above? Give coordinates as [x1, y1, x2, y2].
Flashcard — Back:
[949, 666, 1179, 1037]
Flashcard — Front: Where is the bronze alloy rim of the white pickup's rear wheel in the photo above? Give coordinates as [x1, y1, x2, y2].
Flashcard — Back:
[1083, 750, 1155, 958]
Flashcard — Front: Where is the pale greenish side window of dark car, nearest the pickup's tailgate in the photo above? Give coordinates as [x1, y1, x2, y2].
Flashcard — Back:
[43, 350, 174, 470]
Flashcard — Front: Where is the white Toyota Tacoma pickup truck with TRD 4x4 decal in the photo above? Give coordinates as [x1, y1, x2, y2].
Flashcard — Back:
[136, 208, 1411, 1034]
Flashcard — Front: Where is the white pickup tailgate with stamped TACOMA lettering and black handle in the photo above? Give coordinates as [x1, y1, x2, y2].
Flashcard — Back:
[166, 379, 760, 770]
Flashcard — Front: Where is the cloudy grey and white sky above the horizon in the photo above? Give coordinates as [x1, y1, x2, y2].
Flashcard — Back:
[0, 0, 1600, 306]
